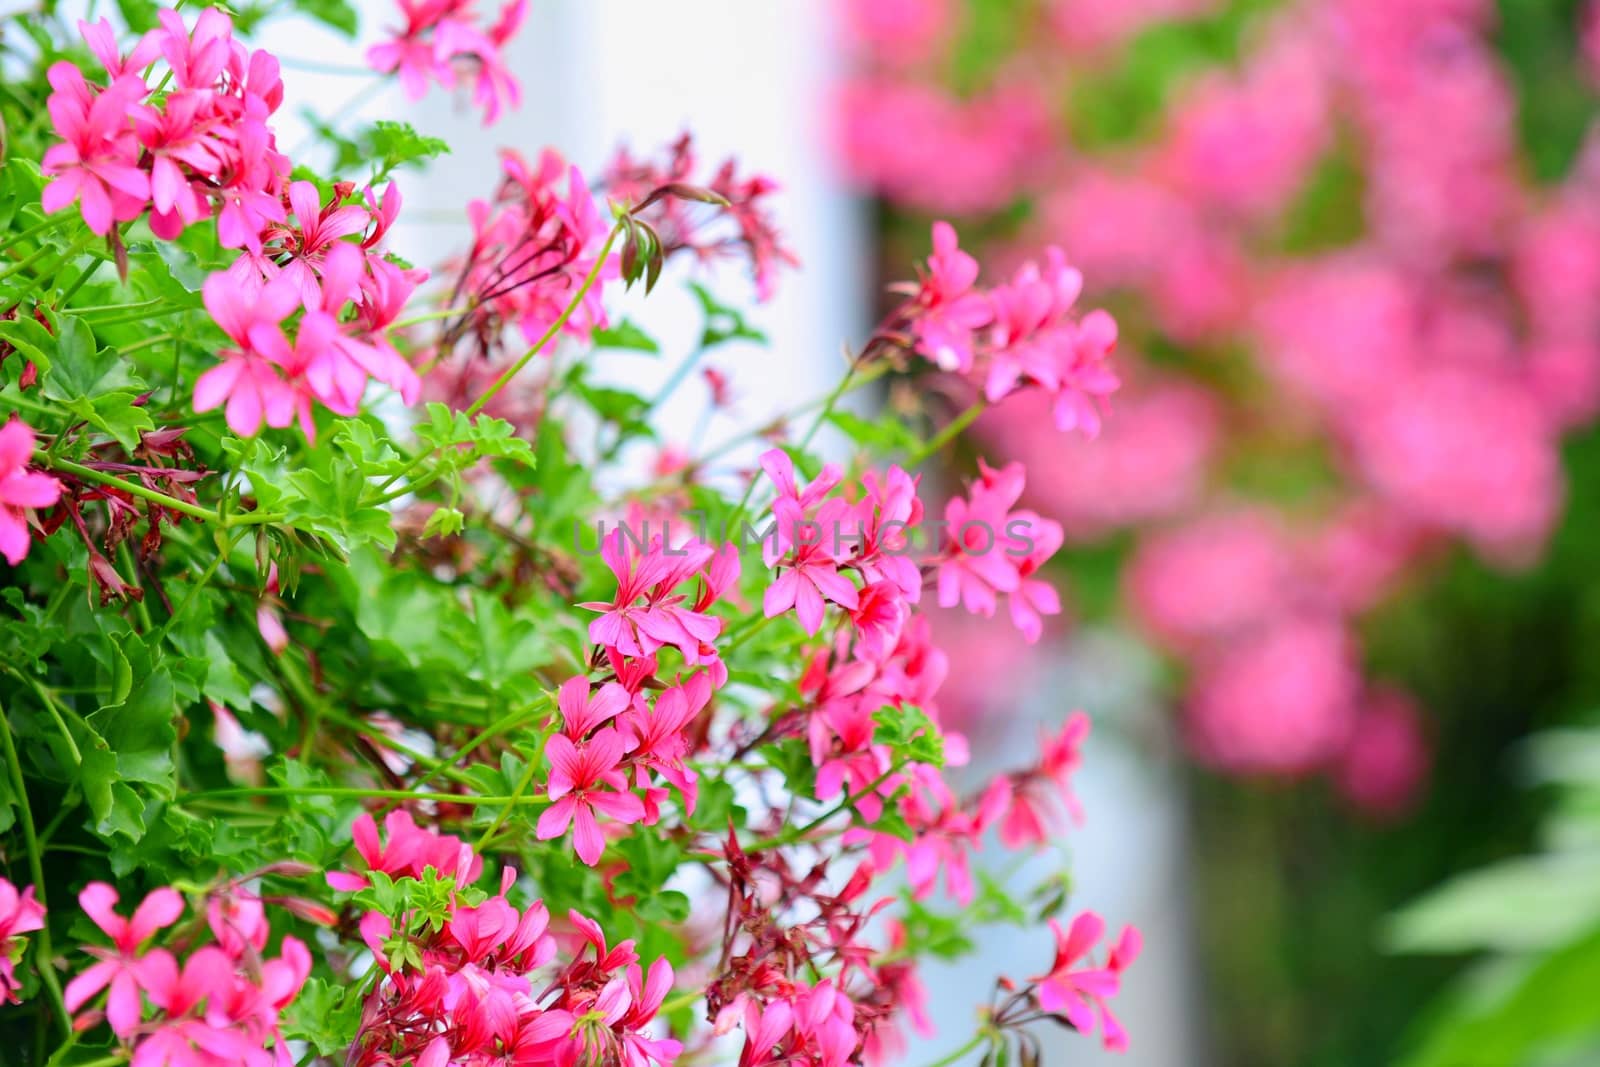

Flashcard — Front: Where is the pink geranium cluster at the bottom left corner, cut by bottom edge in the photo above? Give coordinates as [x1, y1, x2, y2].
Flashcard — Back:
[66, 881, 312, 1067]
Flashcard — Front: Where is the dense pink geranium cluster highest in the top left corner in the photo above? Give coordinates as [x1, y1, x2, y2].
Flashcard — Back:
[43, 8, 290, 250]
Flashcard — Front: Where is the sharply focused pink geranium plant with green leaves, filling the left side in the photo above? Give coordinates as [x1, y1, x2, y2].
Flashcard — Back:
[0, 8, 1145, 1067]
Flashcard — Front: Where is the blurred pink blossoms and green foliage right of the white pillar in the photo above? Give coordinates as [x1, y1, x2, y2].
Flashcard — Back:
[838, 0, 1600, 1067]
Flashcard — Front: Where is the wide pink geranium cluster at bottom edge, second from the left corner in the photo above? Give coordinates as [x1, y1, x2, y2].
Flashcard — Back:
[337, 813, 680, 1067]
